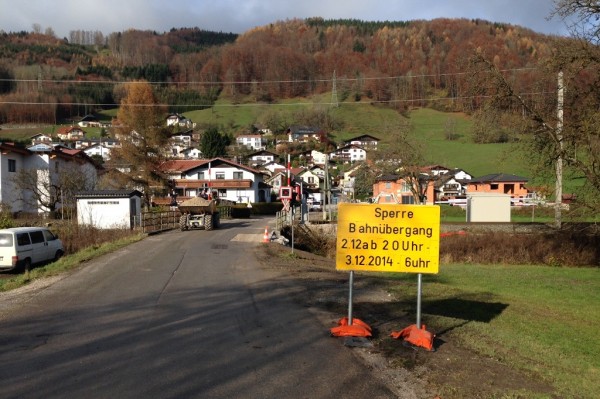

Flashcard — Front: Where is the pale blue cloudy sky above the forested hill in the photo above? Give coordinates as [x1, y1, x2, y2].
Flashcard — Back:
[0, 0, 567, 37]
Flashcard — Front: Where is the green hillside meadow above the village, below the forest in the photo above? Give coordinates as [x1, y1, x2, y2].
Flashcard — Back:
[185, 98, 530, 177]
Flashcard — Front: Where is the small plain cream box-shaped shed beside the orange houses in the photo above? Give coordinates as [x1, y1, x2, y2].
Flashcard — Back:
[467, 193, 510, 222]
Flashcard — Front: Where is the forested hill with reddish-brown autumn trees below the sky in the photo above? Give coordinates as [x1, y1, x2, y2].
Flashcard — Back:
[0, 18, 556, 123]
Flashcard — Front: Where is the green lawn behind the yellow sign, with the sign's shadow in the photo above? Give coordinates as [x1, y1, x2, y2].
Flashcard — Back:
[395, 264, 600, 398]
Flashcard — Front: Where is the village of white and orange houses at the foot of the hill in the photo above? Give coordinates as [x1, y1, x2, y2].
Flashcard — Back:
[0, 114, 539, 219]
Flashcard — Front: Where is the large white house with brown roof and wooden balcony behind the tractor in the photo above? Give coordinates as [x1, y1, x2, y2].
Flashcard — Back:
[160, 158, 271, 203]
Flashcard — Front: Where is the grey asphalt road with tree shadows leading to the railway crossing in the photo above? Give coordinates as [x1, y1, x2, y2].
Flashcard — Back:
[0, 219, 395, 399]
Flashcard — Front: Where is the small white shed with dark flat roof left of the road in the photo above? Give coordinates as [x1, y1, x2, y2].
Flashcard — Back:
[75, 190, 142, 229]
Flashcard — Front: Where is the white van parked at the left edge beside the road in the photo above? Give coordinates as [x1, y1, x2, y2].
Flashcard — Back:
[0, 227, 65, 271]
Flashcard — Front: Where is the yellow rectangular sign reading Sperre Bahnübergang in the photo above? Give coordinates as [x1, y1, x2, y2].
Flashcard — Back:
[336, 203, 440, 274]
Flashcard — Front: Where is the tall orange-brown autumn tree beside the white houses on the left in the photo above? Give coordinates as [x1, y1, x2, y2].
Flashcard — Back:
[110, 81, 169, 206]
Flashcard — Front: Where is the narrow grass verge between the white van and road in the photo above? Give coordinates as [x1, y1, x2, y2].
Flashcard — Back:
[0, 233, 145, 292]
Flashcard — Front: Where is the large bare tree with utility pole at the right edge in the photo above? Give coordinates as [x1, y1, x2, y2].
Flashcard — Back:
[471, 0, 600, 220]
